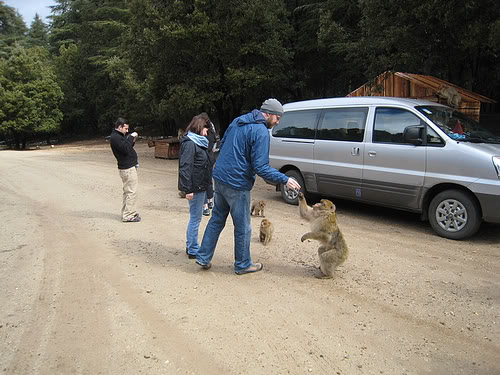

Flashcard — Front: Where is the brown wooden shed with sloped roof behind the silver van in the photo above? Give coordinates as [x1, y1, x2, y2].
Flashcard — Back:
[347, 72, 496, 121]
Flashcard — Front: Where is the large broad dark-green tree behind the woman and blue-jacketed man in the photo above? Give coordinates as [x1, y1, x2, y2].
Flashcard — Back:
[127, 0, 291, 134]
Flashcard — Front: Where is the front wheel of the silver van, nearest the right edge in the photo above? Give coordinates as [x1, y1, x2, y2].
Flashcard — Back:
[429, 190, 481, 240]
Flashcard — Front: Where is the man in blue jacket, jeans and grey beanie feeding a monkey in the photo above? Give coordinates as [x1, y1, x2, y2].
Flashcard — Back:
[196, 98, 300, 275]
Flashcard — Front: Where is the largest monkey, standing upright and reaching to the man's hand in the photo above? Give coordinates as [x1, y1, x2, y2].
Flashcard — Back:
[299, 193, 349, 279]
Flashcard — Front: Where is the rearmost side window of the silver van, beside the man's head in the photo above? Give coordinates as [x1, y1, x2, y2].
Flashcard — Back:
[272, 110, 320, 139]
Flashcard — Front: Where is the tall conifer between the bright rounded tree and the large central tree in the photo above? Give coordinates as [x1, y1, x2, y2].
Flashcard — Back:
[50, 0, 128, 133]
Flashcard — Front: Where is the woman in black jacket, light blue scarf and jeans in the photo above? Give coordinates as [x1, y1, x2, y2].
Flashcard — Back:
[179, 116, 212, 259]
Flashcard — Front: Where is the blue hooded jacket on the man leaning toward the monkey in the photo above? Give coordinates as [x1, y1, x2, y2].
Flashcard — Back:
[213, 109, 288, 190]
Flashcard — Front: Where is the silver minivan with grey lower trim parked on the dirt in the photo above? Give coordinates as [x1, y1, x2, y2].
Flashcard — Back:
[269, 96, 500, 240]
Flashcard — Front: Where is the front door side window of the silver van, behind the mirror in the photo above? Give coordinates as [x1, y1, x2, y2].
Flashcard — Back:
[373, 107, 425, 144]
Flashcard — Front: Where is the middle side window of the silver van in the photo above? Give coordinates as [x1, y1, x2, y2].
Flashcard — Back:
[316, 108, 368, 142]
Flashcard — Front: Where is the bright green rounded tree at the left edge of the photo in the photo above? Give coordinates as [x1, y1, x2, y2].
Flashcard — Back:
[0, 46, 63, 148]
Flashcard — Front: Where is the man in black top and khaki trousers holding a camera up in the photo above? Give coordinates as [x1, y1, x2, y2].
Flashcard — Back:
[109, 118, 141, 223]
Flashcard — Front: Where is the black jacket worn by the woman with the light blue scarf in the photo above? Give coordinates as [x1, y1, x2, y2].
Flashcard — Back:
[178, 136, 212, 194]
